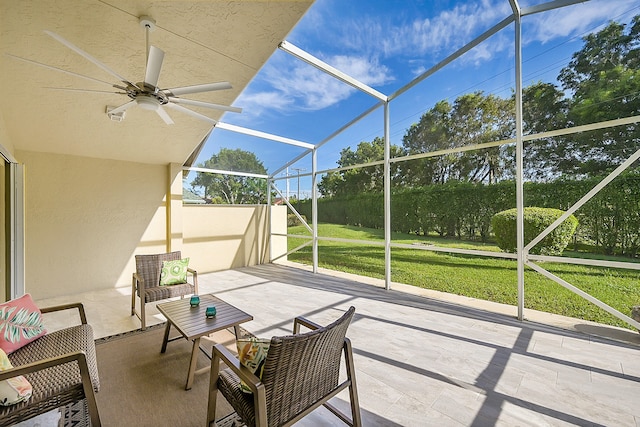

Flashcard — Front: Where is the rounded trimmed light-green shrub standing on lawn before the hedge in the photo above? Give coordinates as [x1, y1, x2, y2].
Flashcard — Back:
[491, 207, 578, 255]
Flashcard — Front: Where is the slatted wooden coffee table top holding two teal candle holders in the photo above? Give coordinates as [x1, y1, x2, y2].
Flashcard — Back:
[157, 295, 253, 340]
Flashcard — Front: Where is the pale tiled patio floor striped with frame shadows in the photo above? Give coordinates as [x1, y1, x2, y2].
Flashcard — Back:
[38, 265, 640, 426]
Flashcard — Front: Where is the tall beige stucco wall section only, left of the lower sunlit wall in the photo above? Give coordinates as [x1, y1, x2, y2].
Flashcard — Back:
[16, 152, 167, 299]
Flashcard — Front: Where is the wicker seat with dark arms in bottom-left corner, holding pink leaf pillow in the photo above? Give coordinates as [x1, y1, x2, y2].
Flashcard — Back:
[0, 303, 101, 427]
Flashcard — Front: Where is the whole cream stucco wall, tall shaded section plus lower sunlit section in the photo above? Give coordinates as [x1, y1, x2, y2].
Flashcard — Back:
[16, 151, 286, 299]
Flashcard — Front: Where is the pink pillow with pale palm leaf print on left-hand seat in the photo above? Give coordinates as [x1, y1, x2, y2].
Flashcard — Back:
[0, 294, 47, 354]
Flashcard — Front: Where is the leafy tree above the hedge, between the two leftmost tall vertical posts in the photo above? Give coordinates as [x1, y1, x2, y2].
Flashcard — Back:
[318, 137, 400, 197]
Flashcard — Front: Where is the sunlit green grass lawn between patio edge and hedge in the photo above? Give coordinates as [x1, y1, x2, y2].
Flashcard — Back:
[288, 224, 640, 329]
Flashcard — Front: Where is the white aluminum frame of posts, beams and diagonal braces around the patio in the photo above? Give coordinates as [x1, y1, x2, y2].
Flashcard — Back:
[194, 0, 640, 328]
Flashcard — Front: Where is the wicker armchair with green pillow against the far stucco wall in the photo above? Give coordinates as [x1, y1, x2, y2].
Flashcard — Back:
[131, 251, 198, 331]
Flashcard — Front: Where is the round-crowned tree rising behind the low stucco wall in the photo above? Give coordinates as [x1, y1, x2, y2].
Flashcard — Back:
[191, 148, 267, 204]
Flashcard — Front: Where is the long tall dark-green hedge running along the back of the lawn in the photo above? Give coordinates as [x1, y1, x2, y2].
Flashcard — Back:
[300, 171, 640, 257]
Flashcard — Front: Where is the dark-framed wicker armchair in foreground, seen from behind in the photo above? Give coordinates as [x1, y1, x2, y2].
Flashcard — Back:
[207, 307, 362, 427]
